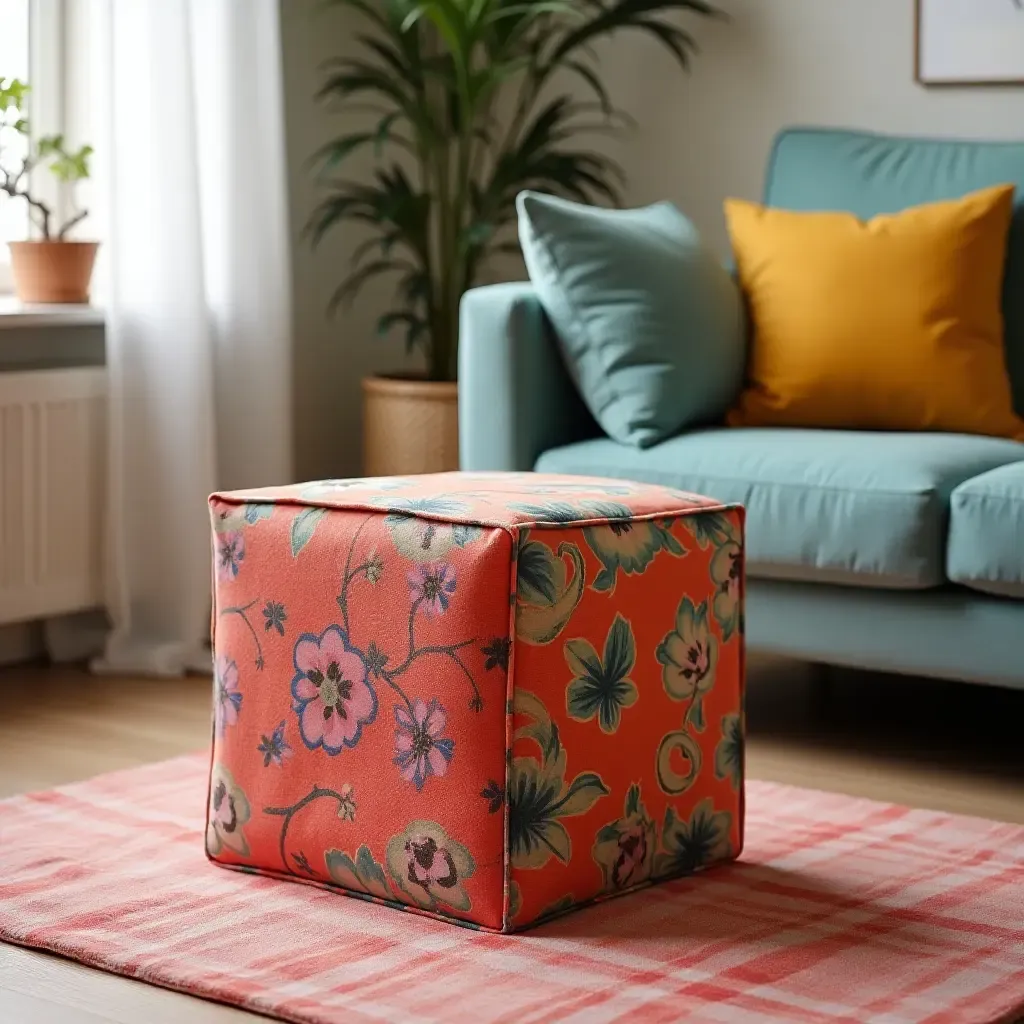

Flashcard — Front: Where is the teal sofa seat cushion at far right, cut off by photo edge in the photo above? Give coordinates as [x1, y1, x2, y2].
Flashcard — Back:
[947, 462, 1024, 599]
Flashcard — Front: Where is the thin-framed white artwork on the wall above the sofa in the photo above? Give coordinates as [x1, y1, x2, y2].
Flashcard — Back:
[914, 0, 1024, 85]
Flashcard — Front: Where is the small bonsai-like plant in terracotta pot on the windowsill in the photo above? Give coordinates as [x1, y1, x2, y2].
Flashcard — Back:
[0, 78, 98, 303]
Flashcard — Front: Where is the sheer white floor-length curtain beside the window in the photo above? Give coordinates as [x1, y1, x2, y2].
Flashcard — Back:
[83, 0, 292, 675]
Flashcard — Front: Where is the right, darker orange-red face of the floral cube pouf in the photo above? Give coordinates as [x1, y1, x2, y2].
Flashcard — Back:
[509, 508, 744, 929]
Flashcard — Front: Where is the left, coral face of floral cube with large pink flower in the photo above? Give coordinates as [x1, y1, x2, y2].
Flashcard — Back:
[207, 500, 512, 929]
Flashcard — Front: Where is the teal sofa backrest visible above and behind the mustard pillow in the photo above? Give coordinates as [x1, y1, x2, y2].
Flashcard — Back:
[765, 129, 1024, 415]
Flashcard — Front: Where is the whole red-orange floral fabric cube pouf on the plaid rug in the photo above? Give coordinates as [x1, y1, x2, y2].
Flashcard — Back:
[206, 473, 743, 931]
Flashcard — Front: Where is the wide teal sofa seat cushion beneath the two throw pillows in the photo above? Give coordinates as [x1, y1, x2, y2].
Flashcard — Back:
[536, 428, 1024, 588]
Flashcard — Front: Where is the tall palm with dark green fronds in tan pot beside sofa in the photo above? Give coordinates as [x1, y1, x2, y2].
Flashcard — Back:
[307, 0, 717, 474]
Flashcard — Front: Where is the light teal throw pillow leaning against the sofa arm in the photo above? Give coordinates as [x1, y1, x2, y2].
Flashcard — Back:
[517, 191, 745, 447]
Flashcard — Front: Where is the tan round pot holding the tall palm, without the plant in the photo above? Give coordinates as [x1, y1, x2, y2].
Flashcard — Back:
[362, 375, 459, 476]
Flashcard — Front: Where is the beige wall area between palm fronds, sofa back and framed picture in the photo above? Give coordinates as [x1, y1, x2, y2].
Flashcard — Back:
[609, 0, 1024, 250]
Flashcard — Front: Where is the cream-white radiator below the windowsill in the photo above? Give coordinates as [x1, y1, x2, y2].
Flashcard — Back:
[0, 368, 106, 624]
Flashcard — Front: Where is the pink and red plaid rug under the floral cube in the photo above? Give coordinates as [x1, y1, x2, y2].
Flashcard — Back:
[0, 756, 1024, 1024]
